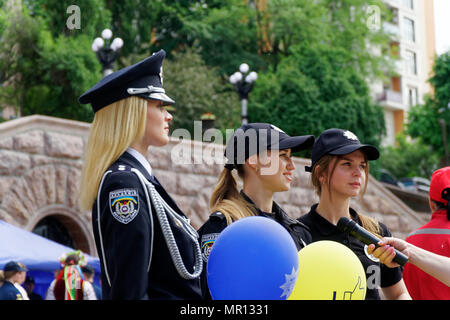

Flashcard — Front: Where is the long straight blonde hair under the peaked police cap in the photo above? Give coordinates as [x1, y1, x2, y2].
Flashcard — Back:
[79, 96, 147, 211]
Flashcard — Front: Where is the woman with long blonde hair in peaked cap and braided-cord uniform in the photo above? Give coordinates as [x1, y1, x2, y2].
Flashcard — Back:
[79, 50, 202, 300]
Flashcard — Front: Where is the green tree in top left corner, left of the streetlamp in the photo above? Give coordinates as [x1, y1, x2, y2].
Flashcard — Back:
[0, 0, 109, 121]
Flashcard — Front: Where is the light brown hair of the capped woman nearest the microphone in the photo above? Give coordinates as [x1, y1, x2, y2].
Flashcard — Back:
[311, 154, 381, 238]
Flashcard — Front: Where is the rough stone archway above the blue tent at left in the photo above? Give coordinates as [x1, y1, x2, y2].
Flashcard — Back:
[0, 159, 96, 255]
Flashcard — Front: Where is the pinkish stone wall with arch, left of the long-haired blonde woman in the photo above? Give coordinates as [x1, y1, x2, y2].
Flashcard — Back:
[0, 116, 95, 253]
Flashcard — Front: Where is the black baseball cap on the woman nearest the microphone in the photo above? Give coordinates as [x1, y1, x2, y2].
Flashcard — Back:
[305, 128, 380, 172]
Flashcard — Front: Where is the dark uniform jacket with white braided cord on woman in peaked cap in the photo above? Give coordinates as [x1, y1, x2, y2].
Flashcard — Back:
[92, 152, 201, 300]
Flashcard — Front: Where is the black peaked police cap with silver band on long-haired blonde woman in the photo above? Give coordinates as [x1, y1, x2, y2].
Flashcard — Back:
[78, 50, 175, 112]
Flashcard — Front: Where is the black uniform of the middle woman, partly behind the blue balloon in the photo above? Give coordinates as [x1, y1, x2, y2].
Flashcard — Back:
[198, 191, 312, 299]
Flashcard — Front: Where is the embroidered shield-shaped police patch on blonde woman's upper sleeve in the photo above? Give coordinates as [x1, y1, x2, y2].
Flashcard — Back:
[109, 189, 139, 224]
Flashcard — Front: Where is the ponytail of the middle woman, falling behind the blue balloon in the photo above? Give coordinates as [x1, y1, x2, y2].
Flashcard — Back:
[209, 165, 256, 225]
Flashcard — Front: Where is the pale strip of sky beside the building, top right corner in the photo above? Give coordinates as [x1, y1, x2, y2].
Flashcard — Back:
[432, 0, 450, 55]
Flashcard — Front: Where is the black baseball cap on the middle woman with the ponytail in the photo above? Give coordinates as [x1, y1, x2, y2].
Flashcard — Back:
[225, 123, 314, 170]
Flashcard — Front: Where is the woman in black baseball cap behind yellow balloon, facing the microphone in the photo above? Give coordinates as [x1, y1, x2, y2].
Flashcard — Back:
[299, 128, 410, 300]
